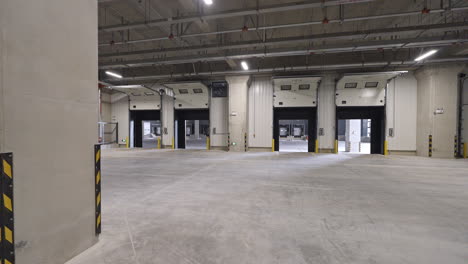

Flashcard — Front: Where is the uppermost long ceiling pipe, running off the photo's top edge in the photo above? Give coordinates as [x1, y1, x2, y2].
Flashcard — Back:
[99, 0, 375, 32]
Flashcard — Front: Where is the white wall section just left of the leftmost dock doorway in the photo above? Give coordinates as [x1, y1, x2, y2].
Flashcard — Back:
[111, 94, 130, 145]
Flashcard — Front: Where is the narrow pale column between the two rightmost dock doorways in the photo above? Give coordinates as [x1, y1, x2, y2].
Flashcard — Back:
[317, 73, 338, 152]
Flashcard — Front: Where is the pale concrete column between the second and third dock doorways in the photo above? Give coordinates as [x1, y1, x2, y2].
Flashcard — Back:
[226, 76, 250, 151]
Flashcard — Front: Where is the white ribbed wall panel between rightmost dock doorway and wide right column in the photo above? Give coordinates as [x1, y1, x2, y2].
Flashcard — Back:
[386, 73, 418, 152]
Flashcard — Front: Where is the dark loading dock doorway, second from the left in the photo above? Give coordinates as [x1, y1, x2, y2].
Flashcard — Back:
[175, 109, 210, 149]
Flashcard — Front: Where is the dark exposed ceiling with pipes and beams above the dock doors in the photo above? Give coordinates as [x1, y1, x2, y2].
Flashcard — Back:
[99, 0, 468, 84]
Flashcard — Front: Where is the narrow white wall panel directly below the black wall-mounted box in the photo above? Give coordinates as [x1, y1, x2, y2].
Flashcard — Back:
[210, 97, 229, 148]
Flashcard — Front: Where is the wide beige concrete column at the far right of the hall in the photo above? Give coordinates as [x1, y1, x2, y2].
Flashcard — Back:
[416, 64, 466, 158]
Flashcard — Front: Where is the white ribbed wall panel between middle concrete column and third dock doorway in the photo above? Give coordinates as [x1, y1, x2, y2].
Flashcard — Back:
[248, 77, 273, 149]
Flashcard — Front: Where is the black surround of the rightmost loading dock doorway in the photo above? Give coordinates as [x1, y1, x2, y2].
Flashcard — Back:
[336, 106, 385, 154]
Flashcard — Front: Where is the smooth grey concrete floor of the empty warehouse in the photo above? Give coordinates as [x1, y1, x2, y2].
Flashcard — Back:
[68, 150, 468, 264]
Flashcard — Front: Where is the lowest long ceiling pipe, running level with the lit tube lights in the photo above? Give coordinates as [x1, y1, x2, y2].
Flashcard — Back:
[104, 57, 468, 82]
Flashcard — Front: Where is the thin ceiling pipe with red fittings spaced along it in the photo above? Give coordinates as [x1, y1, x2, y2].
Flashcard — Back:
[99, 6, 468, 47]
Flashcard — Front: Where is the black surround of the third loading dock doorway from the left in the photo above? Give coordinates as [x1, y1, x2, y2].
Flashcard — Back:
[273, 107, 317, 152]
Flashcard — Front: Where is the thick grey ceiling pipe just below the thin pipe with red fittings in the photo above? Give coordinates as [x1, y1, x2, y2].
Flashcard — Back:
[99, 22, 468, 58]
